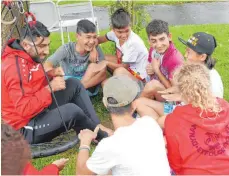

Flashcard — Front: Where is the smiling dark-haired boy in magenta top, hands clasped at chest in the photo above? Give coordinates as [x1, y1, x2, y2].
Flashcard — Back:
[141, 19, 183, 101]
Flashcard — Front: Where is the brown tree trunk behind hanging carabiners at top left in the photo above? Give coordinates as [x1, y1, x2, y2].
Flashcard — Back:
[1, 1, 27, 47]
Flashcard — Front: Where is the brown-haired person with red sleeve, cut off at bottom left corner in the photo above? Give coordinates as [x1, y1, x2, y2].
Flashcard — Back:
[1, 124, 68, 175]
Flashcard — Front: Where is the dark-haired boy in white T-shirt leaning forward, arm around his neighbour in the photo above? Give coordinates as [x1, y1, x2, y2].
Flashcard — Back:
[98, 8, 148, 81]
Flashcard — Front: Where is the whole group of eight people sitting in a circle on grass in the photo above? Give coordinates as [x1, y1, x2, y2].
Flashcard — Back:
[1, 8, 229, 175]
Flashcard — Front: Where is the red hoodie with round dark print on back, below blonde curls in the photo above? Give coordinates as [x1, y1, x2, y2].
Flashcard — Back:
[165, 99, 229, 175]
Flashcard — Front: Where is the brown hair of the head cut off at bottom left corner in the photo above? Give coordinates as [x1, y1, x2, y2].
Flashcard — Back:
[1, 124, 31, 175]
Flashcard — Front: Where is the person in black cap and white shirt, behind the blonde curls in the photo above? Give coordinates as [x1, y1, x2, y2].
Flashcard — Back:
[134, 32, 223, 127]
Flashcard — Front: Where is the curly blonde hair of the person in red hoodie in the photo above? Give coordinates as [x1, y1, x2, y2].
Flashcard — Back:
[174, 62, 220, 113]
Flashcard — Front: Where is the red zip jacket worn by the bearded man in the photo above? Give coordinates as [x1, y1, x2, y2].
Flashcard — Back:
[1, 39, 52, 130]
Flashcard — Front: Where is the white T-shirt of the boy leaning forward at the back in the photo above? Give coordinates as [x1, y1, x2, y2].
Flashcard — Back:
[106, 31, 148, 79]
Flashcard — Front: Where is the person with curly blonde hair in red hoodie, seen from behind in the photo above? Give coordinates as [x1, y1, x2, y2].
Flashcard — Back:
[164, 62, 229, 175]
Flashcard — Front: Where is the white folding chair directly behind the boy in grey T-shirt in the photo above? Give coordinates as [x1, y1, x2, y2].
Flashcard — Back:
[56, 0, 99, 44]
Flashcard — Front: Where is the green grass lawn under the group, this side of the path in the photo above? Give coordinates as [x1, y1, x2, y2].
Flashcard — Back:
[33, 24, 229, 175]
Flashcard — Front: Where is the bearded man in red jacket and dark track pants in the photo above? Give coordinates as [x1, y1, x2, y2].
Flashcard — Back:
[1, 21, 110, 144]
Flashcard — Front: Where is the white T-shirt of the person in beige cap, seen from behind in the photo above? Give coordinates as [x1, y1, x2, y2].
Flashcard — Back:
[87, 116, 170, 176]
